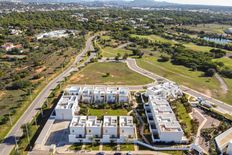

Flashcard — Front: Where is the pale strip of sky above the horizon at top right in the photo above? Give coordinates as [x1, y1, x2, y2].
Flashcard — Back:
[157, 0, 232, 6]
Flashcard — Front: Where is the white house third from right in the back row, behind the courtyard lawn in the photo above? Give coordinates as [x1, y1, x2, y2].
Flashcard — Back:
[94, 87, 106, 103]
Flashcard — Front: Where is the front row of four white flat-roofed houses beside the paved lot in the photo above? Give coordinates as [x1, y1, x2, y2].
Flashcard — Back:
[68, 116, 136, 143]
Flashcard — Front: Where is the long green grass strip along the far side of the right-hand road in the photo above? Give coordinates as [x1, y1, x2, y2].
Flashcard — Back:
[137, 55, 232, 104]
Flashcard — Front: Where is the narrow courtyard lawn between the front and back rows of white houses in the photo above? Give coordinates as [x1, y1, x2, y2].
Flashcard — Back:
[88, 108, 128, 117]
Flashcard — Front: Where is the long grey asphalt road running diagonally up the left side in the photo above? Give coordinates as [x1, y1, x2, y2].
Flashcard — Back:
[0, 36, 94, 155]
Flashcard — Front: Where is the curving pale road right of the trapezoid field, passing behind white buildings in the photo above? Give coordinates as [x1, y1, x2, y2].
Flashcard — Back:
[126, 58, 232, 115]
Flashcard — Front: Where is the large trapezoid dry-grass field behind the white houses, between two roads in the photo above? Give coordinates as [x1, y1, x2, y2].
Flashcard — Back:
[69, 62, 153, 85]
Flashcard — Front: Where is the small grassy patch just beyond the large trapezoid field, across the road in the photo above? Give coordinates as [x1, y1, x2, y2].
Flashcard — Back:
[101, 46, 132, 57]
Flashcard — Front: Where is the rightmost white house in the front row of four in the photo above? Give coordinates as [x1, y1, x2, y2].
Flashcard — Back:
[119, 116, 135, 143]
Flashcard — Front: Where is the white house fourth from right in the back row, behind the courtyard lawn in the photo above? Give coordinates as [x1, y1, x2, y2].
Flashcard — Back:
[81, 86, 94, 103]
